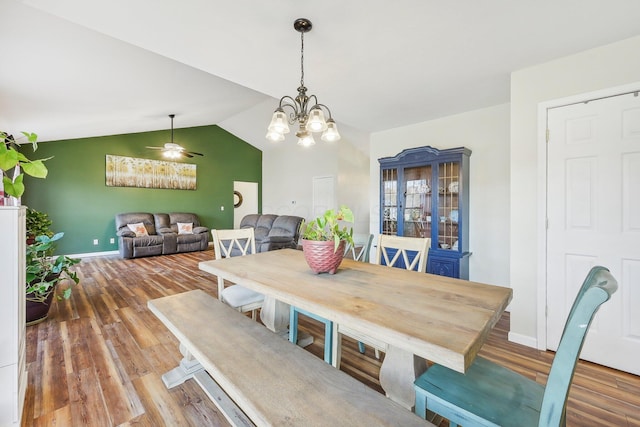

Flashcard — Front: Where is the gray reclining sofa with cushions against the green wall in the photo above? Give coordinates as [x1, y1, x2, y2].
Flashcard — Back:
[116, 212, 209, 258]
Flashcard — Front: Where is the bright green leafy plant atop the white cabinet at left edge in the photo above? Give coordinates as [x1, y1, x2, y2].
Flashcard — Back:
[0, 131, 50, 204]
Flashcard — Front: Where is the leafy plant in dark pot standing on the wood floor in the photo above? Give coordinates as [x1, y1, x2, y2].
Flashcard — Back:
[26, 233, 80, 325]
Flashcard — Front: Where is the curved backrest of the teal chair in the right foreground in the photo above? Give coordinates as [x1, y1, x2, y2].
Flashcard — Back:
[538, 266, 618, 426]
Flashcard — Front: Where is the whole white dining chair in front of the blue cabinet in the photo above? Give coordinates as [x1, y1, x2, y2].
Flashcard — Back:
[331, 234, 431, 369]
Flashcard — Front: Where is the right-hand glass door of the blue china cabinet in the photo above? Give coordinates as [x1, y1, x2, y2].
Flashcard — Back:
[434, 162, 460, 251]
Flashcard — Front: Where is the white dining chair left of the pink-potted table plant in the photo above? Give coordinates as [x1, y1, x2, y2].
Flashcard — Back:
[211, 228, 264, 320]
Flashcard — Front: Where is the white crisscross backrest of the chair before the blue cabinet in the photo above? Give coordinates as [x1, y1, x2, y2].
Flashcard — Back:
[376, 234, 431, 273]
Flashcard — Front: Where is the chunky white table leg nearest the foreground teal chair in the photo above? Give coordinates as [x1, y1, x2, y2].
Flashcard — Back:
[380, 345, 427, 411]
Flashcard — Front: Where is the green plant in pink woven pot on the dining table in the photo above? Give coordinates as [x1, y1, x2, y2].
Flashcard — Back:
[301, 206, 353, 274]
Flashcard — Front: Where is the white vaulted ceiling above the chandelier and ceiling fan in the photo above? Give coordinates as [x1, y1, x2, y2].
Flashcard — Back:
[0, 0, 640, 148]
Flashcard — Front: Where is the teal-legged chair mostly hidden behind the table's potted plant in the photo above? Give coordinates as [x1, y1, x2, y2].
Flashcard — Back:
[289, 234, 373, 364]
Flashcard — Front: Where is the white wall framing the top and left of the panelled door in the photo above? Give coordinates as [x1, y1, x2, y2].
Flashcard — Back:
[512, 33, 640, 346]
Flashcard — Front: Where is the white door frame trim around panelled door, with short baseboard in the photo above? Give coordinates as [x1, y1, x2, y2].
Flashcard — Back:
[536, 81, 640, 350]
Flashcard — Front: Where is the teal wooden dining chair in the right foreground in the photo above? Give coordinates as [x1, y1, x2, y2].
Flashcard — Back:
[414, 266, 618, 427]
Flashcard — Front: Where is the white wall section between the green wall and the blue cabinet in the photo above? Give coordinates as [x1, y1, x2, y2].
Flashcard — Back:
[262, 135, 369, 233]
